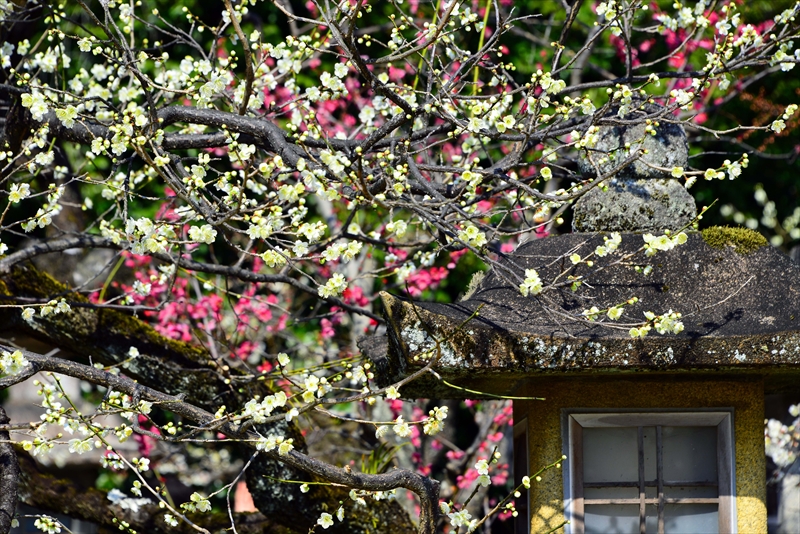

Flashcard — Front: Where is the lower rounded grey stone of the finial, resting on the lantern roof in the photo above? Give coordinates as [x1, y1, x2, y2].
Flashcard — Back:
[572, 178, 697, 232]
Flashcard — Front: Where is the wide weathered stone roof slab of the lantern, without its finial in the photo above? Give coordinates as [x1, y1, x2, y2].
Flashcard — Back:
[370, 234, 800, 397]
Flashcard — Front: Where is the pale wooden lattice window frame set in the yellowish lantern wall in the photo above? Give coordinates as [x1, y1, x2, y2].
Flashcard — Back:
[562, 409, 736, 534]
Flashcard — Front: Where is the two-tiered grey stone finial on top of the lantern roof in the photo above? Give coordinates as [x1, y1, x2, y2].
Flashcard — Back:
[572, 104, 697, 232]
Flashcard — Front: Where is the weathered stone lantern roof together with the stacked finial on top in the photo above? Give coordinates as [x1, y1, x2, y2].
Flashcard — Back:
[359, 106, 800, 398]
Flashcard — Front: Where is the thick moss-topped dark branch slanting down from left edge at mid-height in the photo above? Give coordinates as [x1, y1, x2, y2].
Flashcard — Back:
[0, 265, 255, 408]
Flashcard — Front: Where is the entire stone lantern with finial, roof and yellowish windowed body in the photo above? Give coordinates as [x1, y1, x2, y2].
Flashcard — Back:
[361, 105, 800, 534]
